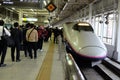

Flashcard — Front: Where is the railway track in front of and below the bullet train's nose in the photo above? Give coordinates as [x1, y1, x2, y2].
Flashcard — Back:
[78, 58, 120, 80]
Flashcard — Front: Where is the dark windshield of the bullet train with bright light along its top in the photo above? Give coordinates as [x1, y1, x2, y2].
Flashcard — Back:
[73, 23, 93, 32]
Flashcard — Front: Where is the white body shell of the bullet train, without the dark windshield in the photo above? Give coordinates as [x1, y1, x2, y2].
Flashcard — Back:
[63, 22, 107, 59]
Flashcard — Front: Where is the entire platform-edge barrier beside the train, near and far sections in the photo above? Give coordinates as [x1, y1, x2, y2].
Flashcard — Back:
[58, 36, 85, 80]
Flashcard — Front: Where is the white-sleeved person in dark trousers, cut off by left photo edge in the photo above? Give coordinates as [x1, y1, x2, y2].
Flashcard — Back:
[0, 20, 11, 67]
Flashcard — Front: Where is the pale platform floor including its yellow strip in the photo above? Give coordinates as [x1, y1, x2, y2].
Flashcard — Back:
[0, 41, 65, 80]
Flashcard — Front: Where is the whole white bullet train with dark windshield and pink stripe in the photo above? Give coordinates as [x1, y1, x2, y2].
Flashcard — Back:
[63, 22, 107, 61]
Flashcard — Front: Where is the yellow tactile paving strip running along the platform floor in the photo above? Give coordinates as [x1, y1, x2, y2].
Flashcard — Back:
[36, 42, 54, 80]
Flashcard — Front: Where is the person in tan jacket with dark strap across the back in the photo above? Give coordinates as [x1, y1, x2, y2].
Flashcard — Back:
[26, 24, 38, 59]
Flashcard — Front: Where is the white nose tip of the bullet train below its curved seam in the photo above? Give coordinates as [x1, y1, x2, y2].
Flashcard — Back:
[79, 47, 107, 58]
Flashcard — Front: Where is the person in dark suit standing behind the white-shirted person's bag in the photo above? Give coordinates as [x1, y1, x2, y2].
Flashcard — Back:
[11, 22, 22, 62]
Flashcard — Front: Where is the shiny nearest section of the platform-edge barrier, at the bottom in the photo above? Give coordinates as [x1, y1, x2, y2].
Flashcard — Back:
[65, 54, 85, 80]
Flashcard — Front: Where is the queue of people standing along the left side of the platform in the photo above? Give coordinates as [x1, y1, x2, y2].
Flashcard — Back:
[0, 20, 61, 67]
